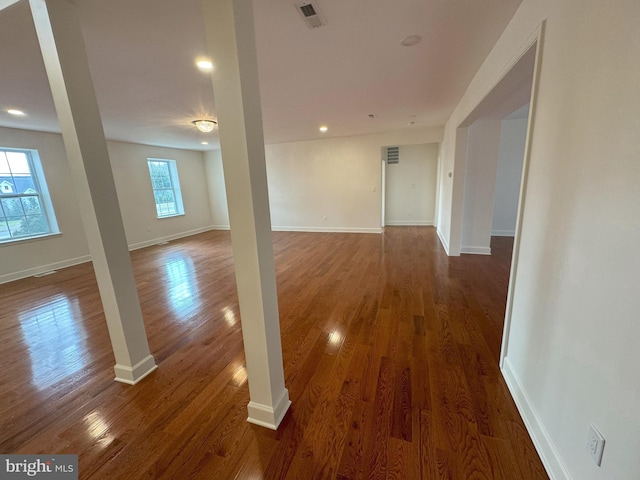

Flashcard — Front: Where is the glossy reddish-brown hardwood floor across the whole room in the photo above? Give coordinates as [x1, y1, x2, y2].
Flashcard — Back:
[0, 227, 548, 480]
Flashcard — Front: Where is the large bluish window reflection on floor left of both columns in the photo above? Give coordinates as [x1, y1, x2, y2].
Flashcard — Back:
[19, 295, 87, 389]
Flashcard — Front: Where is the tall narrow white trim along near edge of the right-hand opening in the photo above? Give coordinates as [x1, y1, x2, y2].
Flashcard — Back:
[500, 20, 546, 366]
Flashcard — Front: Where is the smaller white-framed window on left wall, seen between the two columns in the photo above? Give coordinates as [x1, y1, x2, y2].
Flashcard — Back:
[147, 158, 184, 218]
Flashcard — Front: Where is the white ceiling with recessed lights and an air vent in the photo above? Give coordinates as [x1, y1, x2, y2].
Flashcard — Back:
[0, 0, 521, 150]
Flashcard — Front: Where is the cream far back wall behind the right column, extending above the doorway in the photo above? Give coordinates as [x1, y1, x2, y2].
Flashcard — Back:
[207, 128, 442, 232]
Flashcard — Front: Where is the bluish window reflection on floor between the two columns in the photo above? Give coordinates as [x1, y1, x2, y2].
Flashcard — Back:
[164, 255, 200, 319]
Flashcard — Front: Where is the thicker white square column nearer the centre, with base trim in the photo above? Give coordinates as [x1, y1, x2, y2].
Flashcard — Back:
[204, 0, 291, 430]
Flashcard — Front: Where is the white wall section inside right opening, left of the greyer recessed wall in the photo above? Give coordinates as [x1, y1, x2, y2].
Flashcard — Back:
[461, 118, 500, 255]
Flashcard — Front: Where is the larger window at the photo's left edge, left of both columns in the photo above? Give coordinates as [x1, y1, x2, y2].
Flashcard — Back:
[0, 147, 59, 243]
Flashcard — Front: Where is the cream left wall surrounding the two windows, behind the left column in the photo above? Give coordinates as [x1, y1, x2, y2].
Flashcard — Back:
[0, 128, 211, 283]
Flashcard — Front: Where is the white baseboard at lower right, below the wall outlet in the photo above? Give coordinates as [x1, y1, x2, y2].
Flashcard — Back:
[501, 358, 571, 480]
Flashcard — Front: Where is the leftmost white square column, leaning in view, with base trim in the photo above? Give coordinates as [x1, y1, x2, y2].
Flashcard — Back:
[29, 0, 156, 384]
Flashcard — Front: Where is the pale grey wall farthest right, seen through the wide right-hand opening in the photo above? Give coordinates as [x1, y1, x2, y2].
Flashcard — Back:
[491, 118, 528, 237]
